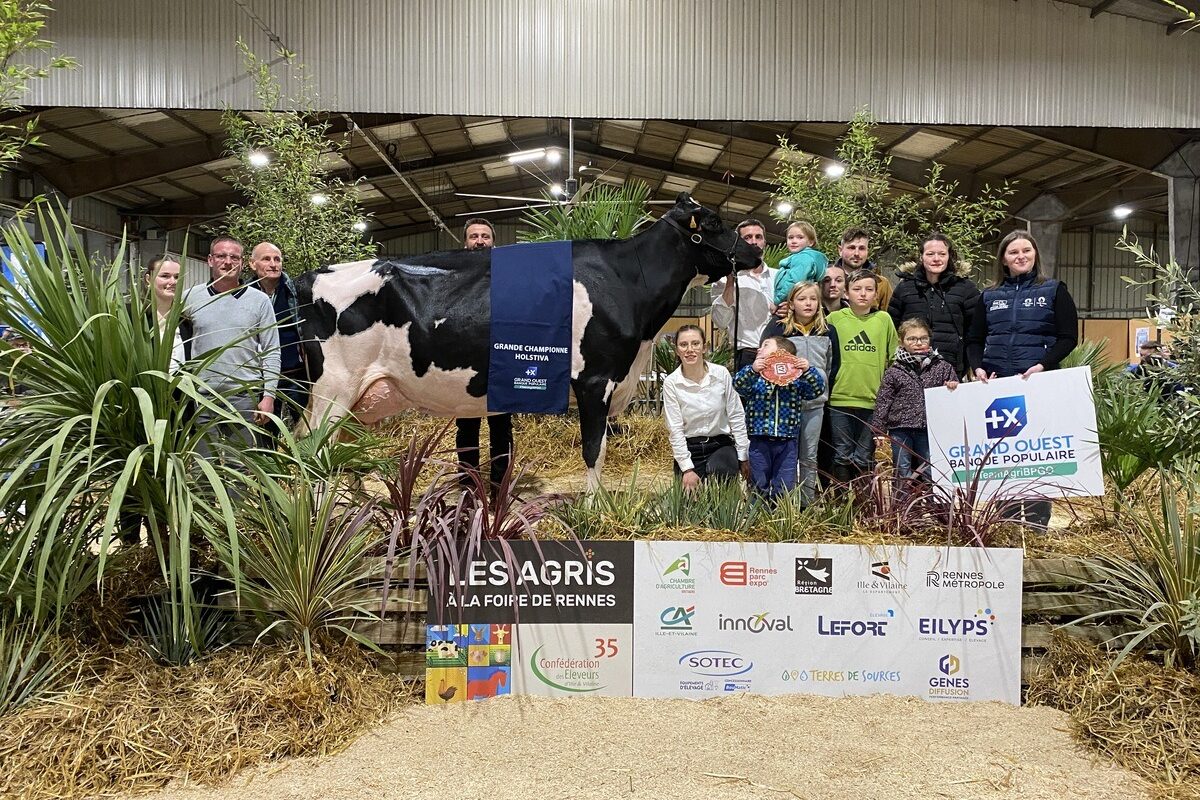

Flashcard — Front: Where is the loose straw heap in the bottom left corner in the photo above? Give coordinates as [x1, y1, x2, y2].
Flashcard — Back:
[0, 645, 413, 798]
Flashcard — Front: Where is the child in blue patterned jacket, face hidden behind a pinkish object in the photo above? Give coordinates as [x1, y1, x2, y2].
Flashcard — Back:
[733, 336, 824, 503]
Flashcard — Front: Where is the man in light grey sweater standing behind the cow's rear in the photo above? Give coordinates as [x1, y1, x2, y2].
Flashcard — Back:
[184, 236, 280, 444]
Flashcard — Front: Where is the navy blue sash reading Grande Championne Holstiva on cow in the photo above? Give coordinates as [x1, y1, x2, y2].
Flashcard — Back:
[487, 241, 574, 414]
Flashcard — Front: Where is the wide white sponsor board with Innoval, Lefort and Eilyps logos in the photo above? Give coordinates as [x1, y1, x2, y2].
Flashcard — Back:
[634, 542, 1022, 704]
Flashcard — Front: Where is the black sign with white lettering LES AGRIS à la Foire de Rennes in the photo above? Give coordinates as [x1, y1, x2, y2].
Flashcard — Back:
[430, 541, 634, 625]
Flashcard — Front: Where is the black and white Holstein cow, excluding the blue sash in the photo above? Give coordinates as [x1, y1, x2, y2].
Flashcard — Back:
[296, 194, 761, 489]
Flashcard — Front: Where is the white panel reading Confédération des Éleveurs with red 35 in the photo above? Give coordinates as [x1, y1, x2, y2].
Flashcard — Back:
[515, 624, 634, 697]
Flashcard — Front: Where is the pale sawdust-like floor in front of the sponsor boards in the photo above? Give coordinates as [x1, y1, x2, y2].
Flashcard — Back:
[140, 694, 1148, 800]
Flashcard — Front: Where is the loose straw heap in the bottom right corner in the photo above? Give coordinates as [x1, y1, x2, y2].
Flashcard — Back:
[1028, 633, 1200, 798]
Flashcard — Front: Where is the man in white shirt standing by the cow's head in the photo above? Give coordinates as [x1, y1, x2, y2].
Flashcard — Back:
[712, 219, 776, 373]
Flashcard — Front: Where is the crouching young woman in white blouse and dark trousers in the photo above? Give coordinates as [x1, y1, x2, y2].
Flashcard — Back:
[662, 325, 750, 492]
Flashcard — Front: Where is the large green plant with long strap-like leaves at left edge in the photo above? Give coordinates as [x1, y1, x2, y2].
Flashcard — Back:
[0, 204, 245, 646]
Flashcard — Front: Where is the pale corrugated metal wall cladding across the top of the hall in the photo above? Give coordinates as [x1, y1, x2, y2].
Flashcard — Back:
[29, 0, 1200, 127]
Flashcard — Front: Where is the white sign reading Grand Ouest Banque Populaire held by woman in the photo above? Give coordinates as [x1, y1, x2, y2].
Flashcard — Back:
[925, 367, 1104, 500]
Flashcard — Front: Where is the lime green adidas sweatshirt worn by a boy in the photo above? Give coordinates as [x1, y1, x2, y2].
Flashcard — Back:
[828, 308, 899, 408]
